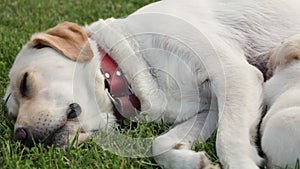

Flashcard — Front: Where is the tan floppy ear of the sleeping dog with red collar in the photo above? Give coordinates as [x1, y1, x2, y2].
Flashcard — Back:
[28, 22, 93, 62]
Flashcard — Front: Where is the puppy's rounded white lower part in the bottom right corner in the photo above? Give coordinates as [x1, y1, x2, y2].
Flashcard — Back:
[262, 107, 300, 168]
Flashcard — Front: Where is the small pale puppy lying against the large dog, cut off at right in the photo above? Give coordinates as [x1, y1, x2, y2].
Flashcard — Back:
[261, 34, 300, 168]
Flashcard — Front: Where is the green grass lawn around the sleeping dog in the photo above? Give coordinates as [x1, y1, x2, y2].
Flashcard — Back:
[0, 0, 217, 169]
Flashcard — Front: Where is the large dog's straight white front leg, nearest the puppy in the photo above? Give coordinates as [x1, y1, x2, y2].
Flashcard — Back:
[211, 61, 263, 169]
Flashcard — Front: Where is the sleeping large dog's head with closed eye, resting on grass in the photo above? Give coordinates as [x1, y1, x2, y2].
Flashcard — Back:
[6, 22, 113, 146]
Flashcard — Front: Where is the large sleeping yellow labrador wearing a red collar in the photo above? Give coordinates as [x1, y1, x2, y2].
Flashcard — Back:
[6, 0, 300, 169]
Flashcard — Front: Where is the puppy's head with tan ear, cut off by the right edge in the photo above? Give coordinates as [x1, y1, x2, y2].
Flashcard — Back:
[264, 34, 300, 107]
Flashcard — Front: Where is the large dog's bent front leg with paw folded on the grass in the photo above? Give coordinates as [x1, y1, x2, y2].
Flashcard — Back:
[152, 109, 219, 169]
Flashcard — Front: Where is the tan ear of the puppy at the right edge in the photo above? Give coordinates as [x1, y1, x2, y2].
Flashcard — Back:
[268, 34, 300, 70]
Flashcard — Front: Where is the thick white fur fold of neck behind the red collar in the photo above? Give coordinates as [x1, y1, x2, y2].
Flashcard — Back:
[85, 20, 168, 119]
